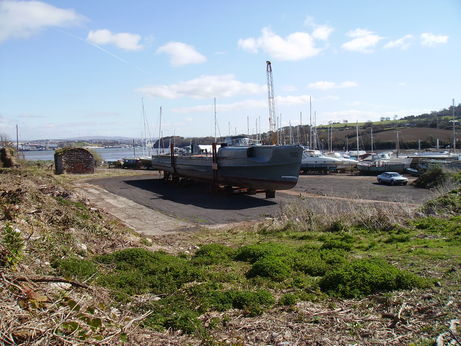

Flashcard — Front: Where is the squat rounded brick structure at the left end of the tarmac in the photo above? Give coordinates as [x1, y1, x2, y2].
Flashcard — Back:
[54, 148, 95, 174]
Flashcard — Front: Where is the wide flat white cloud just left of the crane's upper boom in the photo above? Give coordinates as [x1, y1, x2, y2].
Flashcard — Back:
[138, 74, 267, 99]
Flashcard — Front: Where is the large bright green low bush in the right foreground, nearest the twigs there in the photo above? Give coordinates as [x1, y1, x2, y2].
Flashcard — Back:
[319, 259, 429, 298]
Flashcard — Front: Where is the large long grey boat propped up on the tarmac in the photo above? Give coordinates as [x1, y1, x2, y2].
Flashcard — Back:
[152, 136, 303, 198]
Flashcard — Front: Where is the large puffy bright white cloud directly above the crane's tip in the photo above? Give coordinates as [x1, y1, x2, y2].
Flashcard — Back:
[238, 28, 325, 61]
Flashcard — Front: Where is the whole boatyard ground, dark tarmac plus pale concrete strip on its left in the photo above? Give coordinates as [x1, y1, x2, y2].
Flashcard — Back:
[74, 172, 432, 235]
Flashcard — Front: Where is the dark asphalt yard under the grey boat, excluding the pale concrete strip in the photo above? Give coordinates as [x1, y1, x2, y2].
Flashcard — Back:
[88, 173, 431, 225]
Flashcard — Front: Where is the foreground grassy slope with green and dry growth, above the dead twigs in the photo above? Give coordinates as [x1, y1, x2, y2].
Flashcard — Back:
[0, 165, 461, 343]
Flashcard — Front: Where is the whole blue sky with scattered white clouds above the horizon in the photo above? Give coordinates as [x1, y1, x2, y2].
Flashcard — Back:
[0, 0, 461, 140]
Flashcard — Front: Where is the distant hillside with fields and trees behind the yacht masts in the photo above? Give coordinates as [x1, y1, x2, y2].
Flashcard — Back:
[155, 105, 461, 150]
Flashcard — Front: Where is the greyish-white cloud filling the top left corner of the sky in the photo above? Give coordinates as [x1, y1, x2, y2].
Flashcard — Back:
[0, 0, 85, 43]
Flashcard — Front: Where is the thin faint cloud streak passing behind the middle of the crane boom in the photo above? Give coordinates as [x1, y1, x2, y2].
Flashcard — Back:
[173, 95, 310, 113]
